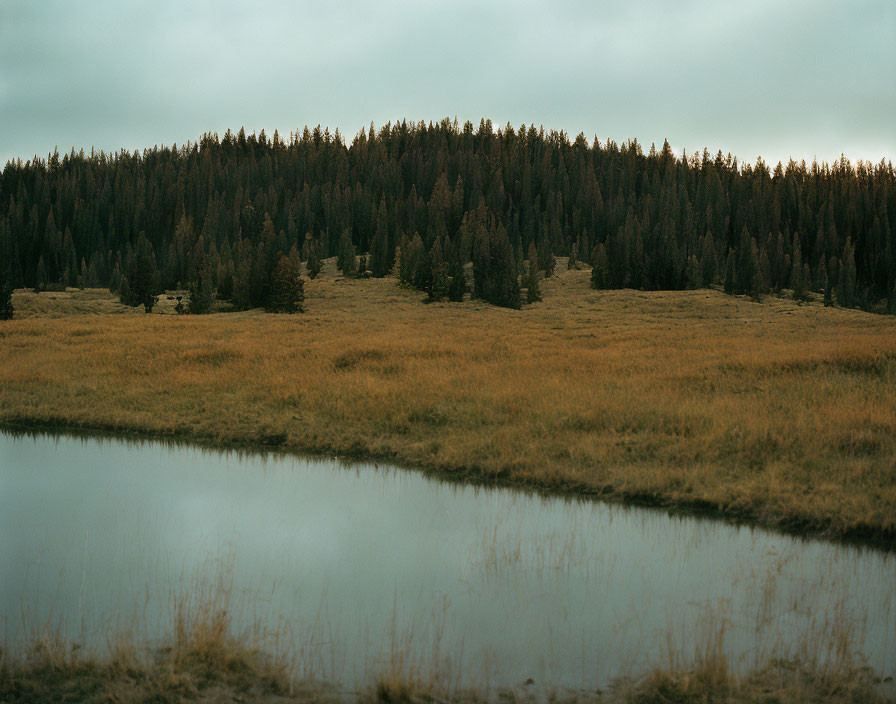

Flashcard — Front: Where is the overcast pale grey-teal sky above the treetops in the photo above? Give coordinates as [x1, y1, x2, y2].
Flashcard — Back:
[0, 0, 896, 168]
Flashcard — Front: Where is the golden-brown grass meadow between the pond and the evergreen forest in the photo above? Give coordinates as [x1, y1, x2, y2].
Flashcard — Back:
[0, 260, 896, 548]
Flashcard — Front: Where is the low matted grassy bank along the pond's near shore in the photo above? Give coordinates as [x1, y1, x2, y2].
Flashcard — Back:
[0, 632, 896, 704]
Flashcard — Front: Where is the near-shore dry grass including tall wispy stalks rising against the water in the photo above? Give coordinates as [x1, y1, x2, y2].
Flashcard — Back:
[0, 576, 894, 704]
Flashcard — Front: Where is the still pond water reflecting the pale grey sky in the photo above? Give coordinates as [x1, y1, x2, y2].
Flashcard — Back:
[0, 433, 896, 689]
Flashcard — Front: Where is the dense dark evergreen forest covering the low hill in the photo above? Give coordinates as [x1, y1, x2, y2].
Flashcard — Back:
[0, 120, 896, 311]
